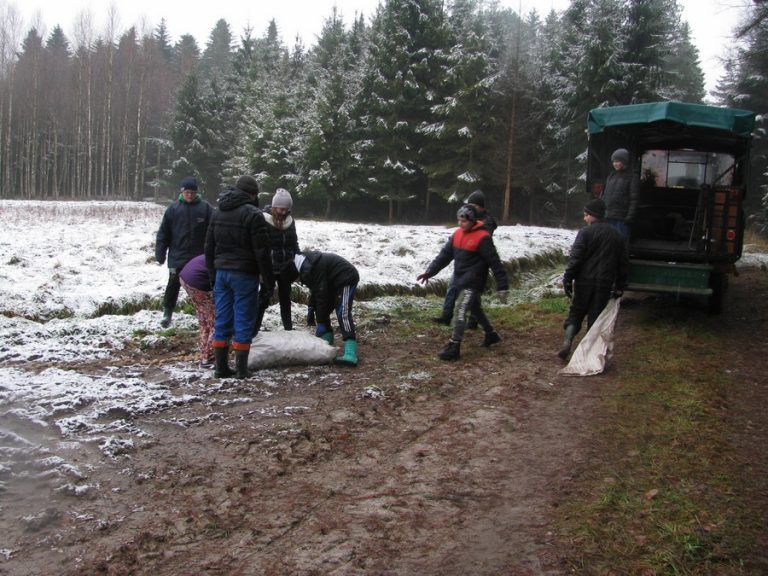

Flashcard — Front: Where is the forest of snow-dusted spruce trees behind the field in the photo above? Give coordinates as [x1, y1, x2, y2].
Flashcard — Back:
[0, 0, 768, 226]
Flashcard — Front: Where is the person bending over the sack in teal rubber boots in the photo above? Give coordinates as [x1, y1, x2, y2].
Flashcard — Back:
[283, 251, 360, 366]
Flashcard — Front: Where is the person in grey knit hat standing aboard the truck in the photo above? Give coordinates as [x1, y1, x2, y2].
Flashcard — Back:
[603, 148, 640, 239]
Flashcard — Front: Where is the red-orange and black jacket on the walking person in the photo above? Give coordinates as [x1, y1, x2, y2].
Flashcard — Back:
[426, 220, 509, 291]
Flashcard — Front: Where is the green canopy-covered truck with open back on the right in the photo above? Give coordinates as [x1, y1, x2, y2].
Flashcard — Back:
[586, 102, 755, 312]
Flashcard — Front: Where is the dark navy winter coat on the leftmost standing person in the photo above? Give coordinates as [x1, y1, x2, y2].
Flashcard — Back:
[155, 194, 213, 269]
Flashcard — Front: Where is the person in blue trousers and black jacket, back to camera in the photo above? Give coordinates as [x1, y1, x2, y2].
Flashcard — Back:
[205, 176, 274, 378]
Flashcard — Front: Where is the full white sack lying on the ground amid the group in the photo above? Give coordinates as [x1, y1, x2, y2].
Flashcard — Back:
[248, 330, 336, 368]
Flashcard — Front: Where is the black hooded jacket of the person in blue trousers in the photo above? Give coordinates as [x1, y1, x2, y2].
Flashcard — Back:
[205, 187, 274, 282]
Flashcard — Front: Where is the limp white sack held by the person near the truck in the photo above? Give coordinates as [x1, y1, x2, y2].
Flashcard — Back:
[558, 298, 621, 376]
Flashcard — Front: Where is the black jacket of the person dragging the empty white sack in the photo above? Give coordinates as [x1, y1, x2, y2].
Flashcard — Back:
[563, 221, 629, 290]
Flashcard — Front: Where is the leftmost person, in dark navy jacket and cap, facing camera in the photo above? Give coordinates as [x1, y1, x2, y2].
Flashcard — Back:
[155, 176, 213, 328]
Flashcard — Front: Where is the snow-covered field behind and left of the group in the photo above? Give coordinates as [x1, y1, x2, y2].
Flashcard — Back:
[0, 201, 575, 489]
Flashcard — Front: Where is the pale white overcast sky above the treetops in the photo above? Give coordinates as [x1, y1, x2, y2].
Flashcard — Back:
[16, 0, 750, 91]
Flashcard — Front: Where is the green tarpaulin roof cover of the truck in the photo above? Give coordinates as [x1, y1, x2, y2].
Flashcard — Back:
[587, 102, 755, 137]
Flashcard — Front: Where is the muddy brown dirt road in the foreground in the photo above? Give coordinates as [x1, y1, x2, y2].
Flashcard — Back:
[0, 270, 768, 576]
